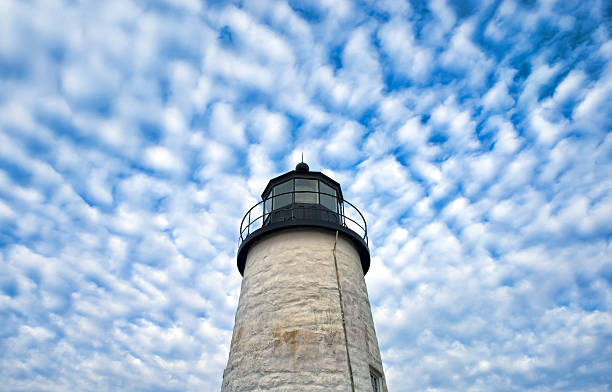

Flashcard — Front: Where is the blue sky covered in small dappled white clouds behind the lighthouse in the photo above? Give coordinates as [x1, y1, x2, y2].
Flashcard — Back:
[0, 0, 612, 392]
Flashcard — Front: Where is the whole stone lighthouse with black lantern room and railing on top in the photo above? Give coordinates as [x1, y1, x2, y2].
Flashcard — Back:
[221, 162, 387, 392]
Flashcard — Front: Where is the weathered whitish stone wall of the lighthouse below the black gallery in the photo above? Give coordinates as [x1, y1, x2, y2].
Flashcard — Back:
[221, 229, 386, 392]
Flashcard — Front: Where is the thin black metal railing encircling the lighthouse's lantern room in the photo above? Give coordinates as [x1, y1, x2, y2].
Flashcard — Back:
[240, 191, 368, 246]
